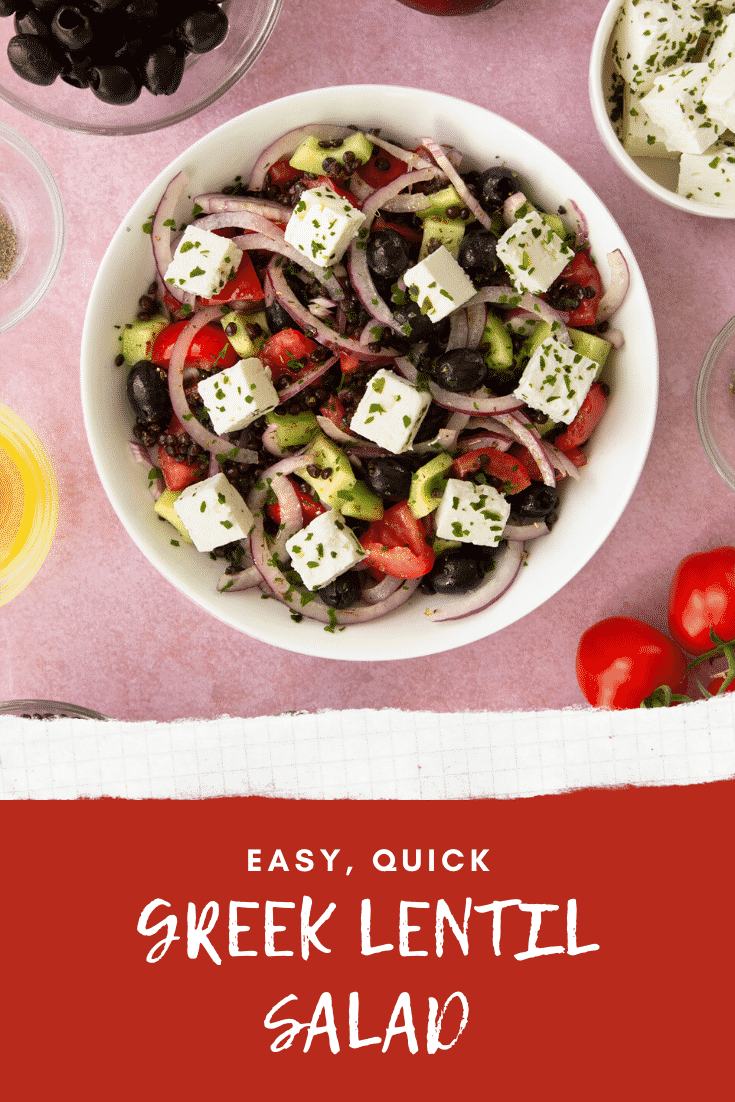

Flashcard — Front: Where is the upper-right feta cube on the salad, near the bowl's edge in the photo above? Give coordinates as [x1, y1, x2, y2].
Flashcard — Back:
[496, 208, 574, 294]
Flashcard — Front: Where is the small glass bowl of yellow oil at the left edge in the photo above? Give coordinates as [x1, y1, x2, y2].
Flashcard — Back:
[0, 406, 58, 607]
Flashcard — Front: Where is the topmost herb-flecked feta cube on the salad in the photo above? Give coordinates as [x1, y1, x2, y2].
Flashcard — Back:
[284, 184, 365, 268]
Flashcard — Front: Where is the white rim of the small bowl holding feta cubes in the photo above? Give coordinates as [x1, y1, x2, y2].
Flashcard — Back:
[587, 0, 735, 218]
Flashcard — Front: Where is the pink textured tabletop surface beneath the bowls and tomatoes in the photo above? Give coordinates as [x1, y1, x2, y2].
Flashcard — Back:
[0, 0, 735, 721]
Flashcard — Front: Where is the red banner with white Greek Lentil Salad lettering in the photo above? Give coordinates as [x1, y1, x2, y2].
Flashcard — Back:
[0, 781, 735, 1102]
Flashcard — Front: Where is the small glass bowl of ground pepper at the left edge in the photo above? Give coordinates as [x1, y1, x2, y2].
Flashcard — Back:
[0, 122, 66, 333]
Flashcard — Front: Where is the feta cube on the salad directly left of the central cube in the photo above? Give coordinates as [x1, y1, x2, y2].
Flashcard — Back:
[198, 356, 279, 433]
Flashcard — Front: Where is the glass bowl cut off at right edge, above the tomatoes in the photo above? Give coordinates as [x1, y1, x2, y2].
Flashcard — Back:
[694, 317, 735, 489]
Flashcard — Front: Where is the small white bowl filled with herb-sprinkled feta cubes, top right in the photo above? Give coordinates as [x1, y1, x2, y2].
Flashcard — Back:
[590, 0, 735, 218]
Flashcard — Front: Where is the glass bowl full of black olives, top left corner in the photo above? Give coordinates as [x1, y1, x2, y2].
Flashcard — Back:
[0, 0, 282, 134]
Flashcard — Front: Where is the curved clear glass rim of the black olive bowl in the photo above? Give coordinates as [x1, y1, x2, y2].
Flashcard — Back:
[0, 0, 283, 138]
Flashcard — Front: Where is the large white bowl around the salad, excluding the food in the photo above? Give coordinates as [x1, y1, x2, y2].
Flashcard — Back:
[82, 85, 658, 660]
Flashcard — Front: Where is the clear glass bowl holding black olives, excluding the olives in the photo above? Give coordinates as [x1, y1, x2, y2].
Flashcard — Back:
[0, 0, 282, 136]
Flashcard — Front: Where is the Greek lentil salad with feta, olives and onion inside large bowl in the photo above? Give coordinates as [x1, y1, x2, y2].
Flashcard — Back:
[118, 123, 628, 630]
